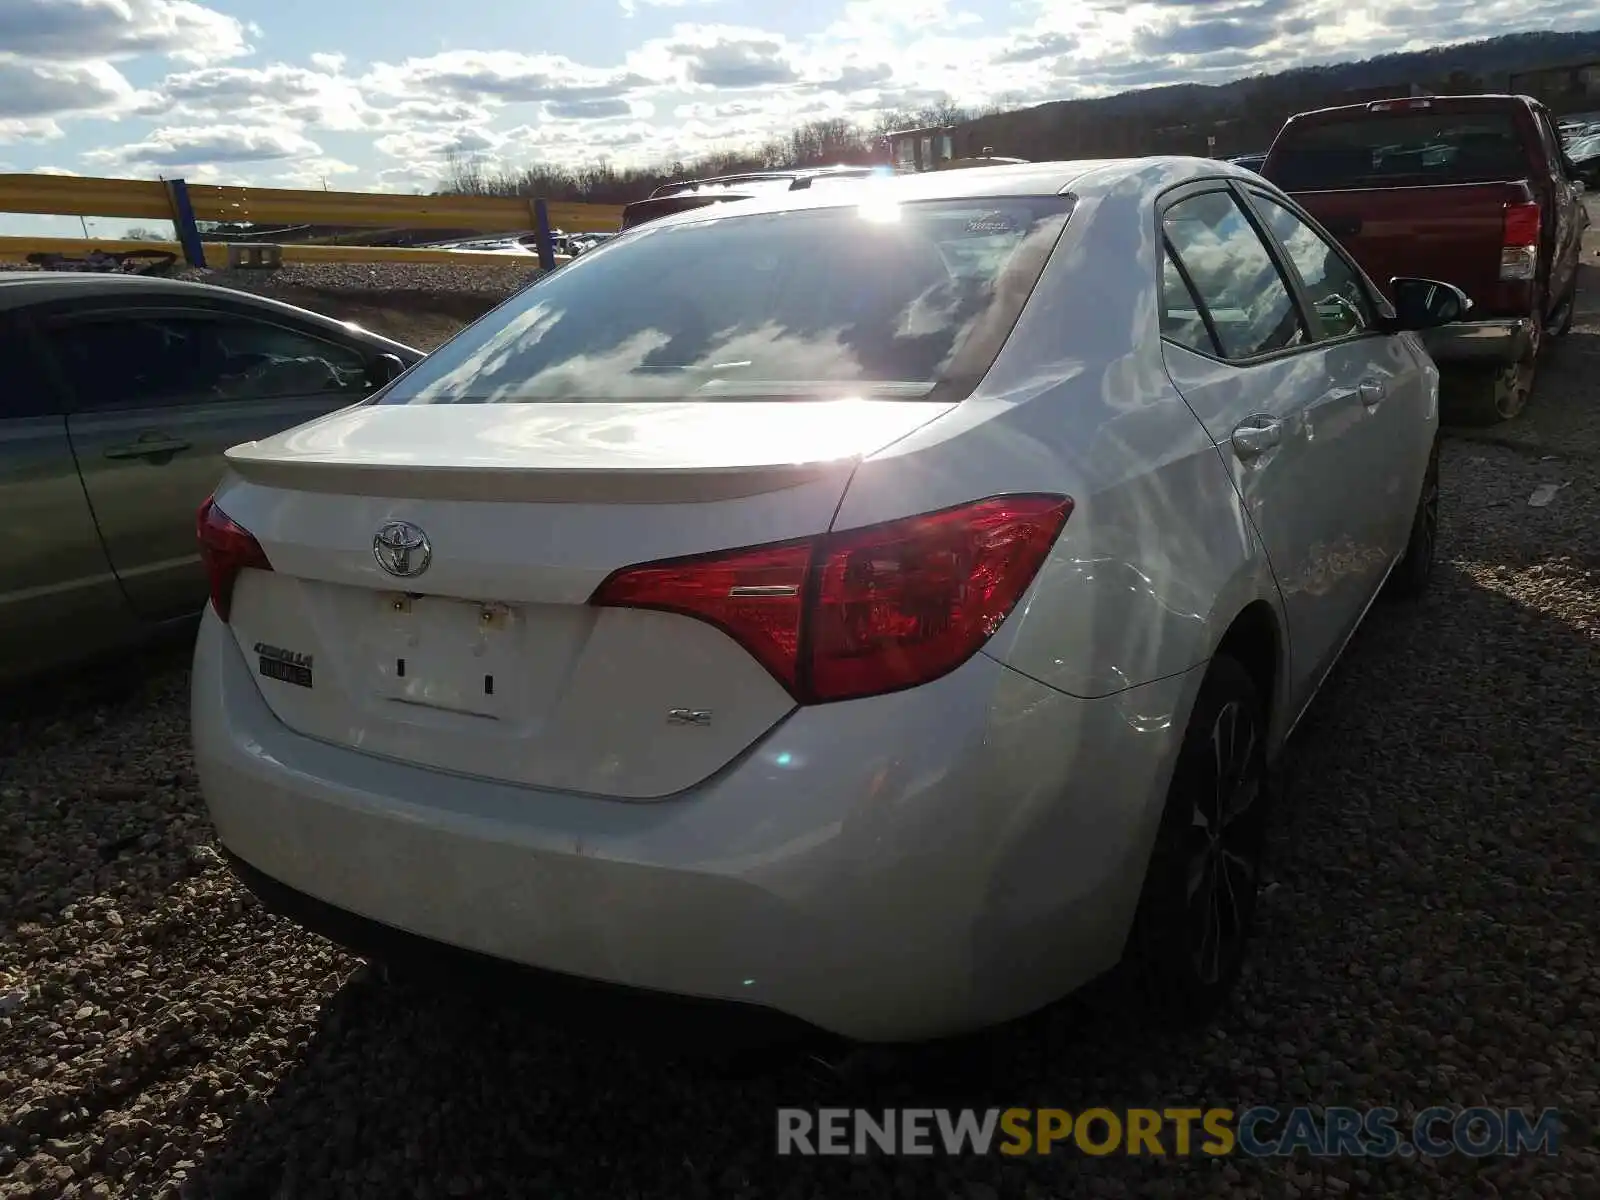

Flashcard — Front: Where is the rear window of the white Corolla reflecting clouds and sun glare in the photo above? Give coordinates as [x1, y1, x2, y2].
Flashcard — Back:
[378, 197, 1072, 405]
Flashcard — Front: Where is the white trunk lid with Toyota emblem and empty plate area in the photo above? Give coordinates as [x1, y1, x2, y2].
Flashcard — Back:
[216, 400, 950, 800]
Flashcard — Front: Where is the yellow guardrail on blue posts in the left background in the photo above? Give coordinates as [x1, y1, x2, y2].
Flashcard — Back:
[0, 174, 622, 266]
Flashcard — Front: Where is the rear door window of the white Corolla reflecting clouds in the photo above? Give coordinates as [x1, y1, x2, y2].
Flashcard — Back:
[1162, 192, 1307, 360]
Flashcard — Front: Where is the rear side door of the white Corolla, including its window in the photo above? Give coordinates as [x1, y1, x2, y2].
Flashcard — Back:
[1160, 179, 1371, 710]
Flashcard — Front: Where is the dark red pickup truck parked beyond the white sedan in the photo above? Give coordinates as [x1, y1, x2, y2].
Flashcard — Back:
[1261, 96, 1589, 424]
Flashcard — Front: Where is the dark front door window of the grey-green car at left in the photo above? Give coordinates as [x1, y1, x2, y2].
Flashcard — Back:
[48, 314, 371, 413]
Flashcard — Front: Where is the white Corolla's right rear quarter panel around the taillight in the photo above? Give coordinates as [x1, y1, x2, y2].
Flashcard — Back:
[834, 168, 1277, 698]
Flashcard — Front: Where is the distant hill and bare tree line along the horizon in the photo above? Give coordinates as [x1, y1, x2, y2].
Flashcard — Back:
[438, 32, 1600, 205]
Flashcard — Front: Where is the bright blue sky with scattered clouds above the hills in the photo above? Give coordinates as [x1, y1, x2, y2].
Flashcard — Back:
[0, 0, 1600, 235]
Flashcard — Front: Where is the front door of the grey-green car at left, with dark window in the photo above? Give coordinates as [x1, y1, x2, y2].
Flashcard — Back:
[42, 301, 385, 621]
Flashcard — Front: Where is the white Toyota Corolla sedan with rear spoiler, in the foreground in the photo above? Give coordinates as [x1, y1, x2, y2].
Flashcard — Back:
[194, 158, 1470, 1042]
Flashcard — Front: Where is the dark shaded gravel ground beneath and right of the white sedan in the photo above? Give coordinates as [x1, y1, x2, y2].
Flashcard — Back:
[186, 540, 1600, 1200]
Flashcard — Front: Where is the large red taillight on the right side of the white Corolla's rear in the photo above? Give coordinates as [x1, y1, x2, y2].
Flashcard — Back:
[590, 496, 1072, 704]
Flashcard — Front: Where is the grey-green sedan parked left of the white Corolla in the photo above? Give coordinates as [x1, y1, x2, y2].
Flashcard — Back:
[0, 272, 422, 680]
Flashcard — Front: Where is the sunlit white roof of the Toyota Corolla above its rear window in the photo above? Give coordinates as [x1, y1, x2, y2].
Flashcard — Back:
[630, 155, 1262, 232]
